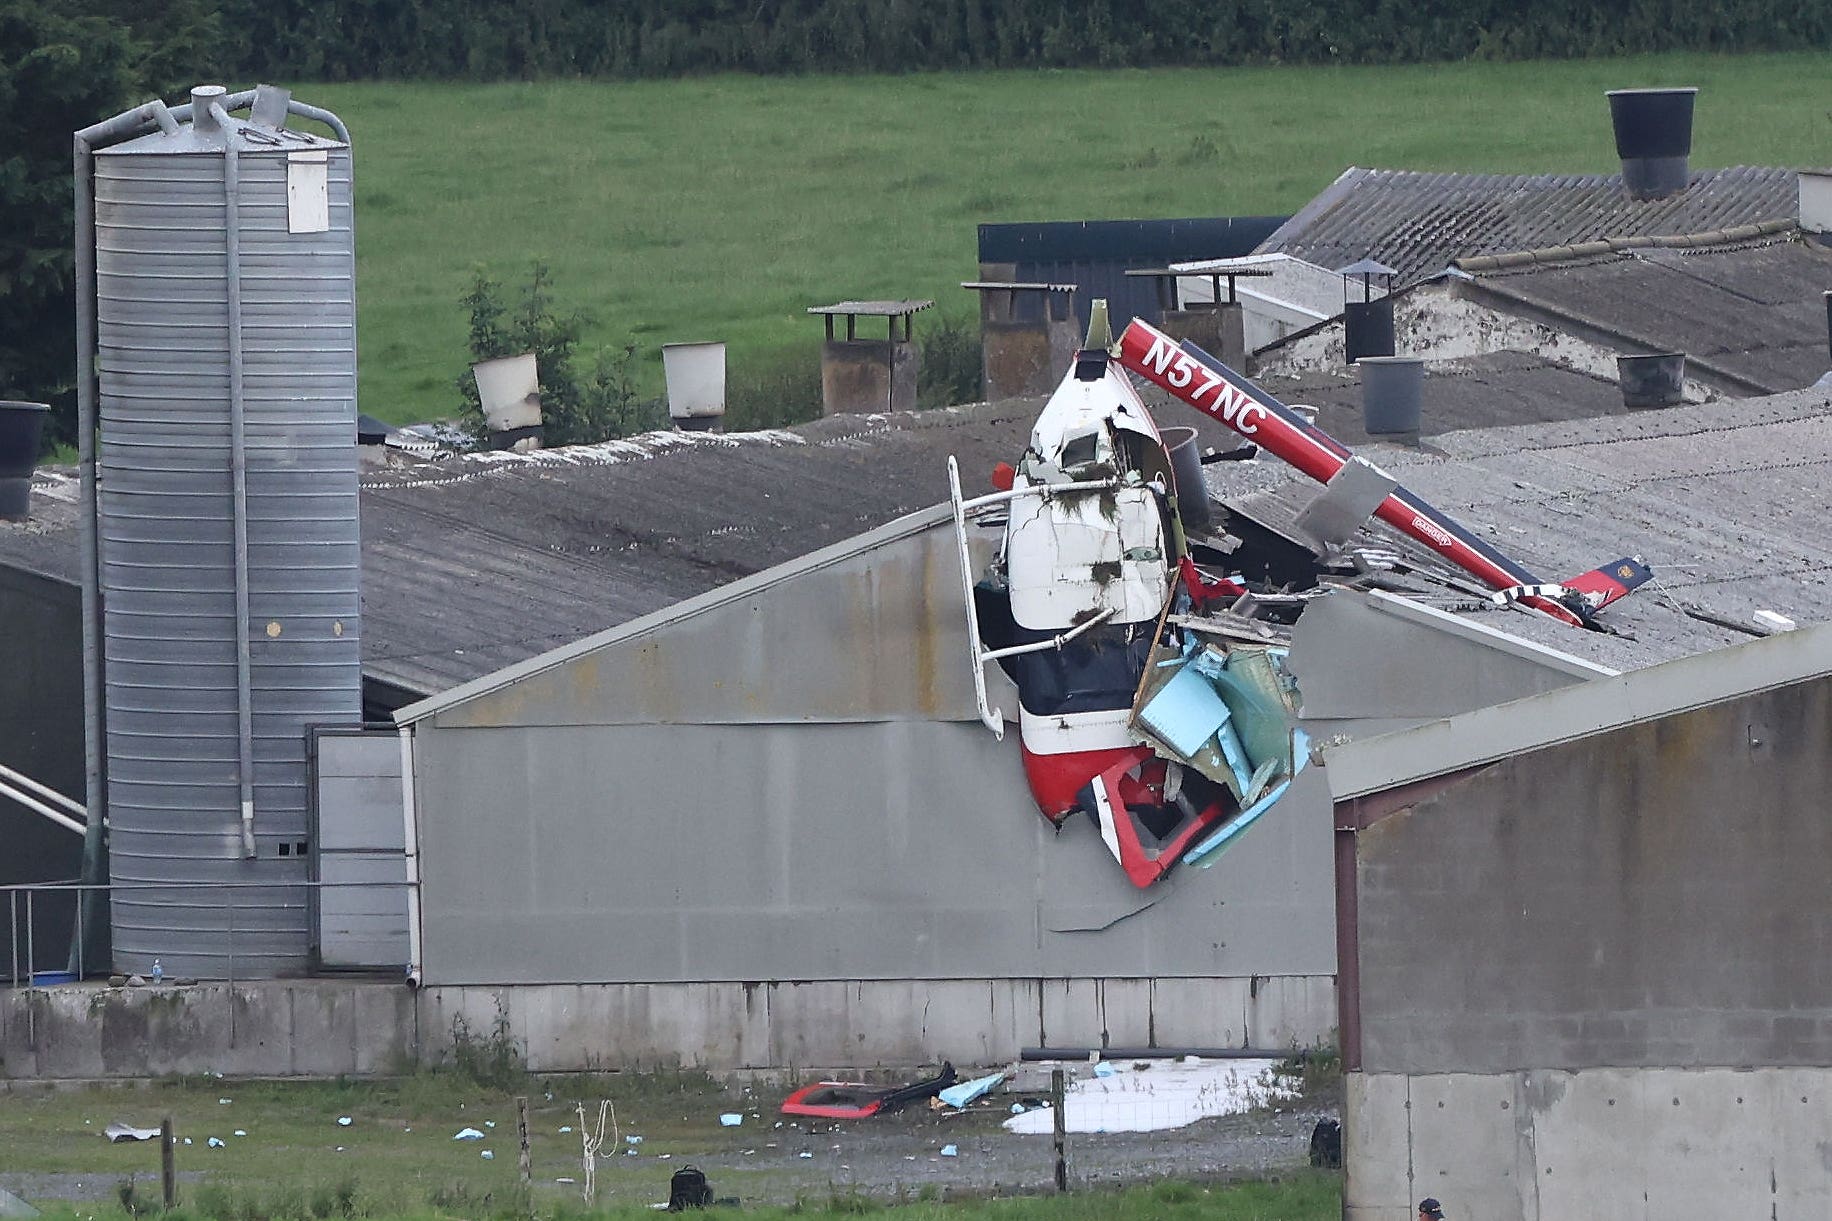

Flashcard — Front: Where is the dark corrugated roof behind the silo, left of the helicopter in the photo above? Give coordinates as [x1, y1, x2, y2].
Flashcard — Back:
[0, 400, 1233, 695]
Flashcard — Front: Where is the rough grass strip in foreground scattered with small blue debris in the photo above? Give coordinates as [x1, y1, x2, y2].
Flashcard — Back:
[0, 1073, 1341, 1221]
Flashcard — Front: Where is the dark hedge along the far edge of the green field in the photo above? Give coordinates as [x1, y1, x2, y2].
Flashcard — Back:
[218, 0, 1832, 81]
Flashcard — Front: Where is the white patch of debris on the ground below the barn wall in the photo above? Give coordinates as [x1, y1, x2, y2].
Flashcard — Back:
[1004, 1058, 1297, 1135]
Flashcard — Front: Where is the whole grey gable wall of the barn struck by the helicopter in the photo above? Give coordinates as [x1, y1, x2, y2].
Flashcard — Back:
[407, 512, 1336, 1063]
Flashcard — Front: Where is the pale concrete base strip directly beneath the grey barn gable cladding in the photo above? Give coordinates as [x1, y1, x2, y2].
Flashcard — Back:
[420, 975, 1336, 1073]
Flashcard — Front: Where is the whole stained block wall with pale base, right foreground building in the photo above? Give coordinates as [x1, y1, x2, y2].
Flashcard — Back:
[1345, 671, 1832, 1221]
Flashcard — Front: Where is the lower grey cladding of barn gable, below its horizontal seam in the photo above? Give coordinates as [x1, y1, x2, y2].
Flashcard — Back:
[416, 721, 1334, 985]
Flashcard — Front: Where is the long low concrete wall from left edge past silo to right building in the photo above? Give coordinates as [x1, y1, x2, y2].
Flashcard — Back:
[0, 975, 1336, 1080]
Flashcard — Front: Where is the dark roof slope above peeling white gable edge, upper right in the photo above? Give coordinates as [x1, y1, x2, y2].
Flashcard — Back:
[1456, 227, 1832, 394]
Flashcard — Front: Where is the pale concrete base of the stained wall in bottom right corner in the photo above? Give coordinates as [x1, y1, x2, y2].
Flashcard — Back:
[1343, 1069, 1832, 1221]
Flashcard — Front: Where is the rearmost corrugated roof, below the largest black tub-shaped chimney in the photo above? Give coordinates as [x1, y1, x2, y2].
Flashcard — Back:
[1257, 165, 1797, 284]
